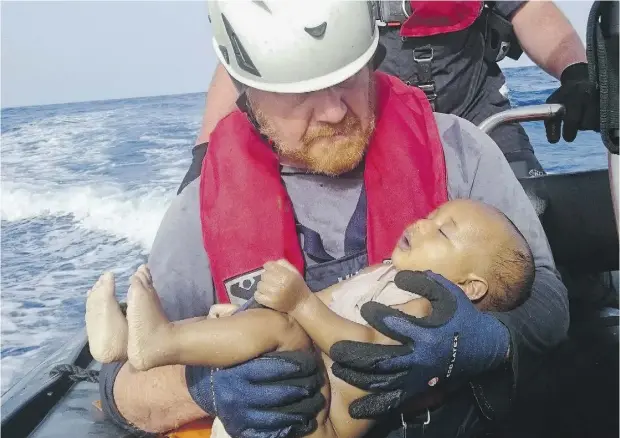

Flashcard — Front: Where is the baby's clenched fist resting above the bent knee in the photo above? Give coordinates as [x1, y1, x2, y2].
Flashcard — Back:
[254, 259, 312, 313]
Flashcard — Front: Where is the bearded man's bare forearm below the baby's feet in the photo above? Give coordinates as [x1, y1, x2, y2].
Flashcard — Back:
[101, 364, 207, 433]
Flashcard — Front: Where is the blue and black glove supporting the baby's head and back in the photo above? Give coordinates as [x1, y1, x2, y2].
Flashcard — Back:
[329, 271, 510, 418]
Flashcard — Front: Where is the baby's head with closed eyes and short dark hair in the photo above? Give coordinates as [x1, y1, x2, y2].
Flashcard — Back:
[392, 199, 534, 312]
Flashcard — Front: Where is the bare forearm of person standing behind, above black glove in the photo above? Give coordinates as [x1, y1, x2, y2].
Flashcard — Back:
[512, 1, 587, 79]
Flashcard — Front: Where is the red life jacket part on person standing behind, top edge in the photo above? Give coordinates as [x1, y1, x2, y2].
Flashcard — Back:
[400, 0, 484, 38]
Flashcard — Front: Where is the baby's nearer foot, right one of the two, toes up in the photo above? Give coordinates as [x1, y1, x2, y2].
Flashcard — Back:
[127, 265, 174, 371]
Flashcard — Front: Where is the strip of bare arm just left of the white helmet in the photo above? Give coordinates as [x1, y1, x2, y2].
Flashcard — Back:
[196, 63, 237, 145]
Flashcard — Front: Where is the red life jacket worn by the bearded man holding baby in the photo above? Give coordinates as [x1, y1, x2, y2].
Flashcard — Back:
[200, 72, 448, 303]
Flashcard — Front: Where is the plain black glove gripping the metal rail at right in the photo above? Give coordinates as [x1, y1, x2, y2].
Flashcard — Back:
[545, 62, 600, 143]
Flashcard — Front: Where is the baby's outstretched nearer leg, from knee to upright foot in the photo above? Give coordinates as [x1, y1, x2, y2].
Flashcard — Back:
[127, 267, 312, 371]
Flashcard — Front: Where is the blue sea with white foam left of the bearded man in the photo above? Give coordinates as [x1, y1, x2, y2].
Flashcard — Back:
[0, 96, 202, 391]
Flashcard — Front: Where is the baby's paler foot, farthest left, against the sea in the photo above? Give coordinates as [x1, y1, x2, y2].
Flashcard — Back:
[85, 272, 127, 363]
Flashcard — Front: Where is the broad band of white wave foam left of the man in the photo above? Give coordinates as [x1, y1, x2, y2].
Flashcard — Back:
[1, 181, 172, 250]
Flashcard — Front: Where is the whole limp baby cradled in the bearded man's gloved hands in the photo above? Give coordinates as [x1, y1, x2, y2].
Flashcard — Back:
[86, 200, 534, 437]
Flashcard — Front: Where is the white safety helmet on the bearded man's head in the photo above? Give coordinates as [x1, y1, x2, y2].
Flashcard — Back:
[208, 0, 379, 93]
